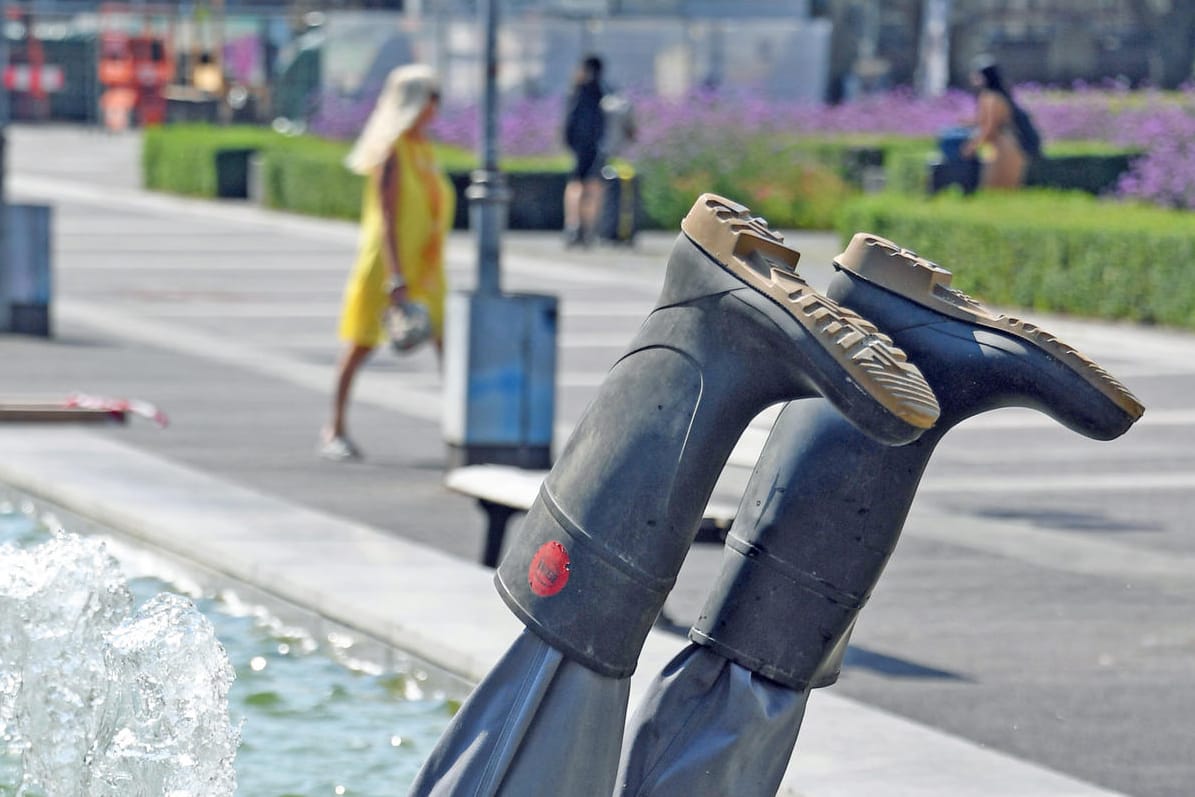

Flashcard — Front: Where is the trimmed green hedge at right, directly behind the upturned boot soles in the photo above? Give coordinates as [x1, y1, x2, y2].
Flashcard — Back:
[839, 190, 1195, 329]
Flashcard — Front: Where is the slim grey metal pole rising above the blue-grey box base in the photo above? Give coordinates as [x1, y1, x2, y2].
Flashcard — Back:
[465, 0, 510, 295]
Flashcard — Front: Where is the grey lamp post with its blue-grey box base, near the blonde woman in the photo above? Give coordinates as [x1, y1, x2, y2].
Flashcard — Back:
[443, 0, 557, 473]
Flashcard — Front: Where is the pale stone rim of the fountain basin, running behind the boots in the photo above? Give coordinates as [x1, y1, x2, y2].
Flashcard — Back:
[0, 428, 1113, 797]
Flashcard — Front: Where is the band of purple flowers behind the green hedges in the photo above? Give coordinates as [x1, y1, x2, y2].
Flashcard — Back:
[311, 85, 1195, 208]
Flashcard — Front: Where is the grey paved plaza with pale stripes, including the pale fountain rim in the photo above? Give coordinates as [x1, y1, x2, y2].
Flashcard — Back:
[0, 121, 1195, 797]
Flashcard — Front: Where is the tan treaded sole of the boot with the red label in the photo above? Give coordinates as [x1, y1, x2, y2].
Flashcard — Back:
[681, 194, 939, 437]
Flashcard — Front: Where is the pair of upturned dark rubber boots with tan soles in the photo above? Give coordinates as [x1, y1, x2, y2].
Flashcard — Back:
[495, 194, 1142, 688]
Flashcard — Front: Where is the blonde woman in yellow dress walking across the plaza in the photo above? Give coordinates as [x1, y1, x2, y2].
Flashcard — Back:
[319, 65, 455, 460]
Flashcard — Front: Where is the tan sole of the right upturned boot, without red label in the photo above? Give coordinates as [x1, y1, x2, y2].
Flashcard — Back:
[834, 233, 1145, 421]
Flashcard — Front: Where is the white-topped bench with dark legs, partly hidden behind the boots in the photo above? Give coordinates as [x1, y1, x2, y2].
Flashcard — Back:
[445, 465, 739, 568]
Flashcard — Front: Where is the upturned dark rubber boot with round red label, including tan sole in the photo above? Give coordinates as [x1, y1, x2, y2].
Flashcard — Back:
[495, 194, 938, 678]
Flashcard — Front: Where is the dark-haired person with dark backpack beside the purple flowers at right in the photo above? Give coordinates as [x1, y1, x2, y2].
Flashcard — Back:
[961, 59, 1041, 189]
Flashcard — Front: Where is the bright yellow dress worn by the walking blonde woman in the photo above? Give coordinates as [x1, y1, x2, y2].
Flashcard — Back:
[341, 135, 456, 348]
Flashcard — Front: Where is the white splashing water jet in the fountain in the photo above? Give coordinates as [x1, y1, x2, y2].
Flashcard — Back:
[0, 532, 239, 797]
